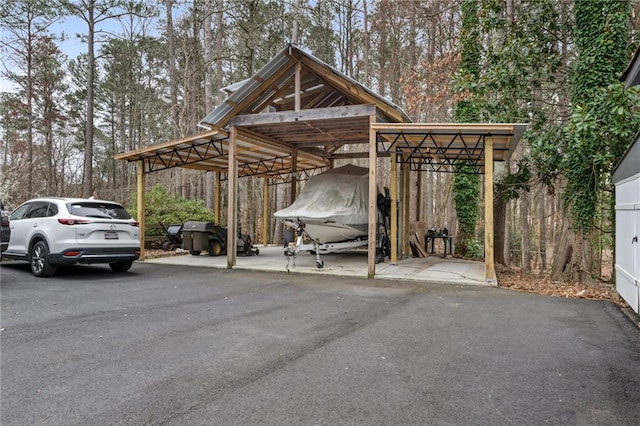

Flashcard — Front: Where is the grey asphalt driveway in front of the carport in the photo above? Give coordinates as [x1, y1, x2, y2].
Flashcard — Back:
[0, 262, 640, 426]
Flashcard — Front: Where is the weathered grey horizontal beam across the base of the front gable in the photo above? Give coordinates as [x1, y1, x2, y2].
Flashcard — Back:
[231, 104, 376, 127]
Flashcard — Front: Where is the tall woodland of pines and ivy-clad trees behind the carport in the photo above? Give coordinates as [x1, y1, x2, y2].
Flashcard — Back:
[0, 0, 640, 282]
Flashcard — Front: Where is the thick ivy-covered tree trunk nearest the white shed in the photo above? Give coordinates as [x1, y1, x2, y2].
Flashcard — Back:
[552, 0, 638, 281]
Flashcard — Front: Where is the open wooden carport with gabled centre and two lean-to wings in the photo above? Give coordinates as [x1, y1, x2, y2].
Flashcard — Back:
[115, 45, 526, 282]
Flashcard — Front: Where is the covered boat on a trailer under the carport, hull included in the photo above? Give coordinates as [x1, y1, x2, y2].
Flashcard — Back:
[274, 164, 369, 246]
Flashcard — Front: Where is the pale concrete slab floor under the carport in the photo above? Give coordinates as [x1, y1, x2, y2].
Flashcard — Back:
[144, 246, 488, 286]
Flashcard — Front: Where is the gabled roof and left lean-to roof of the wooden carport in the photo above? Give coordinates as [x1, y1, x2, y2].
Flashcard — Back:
[115, 45, 410, 176]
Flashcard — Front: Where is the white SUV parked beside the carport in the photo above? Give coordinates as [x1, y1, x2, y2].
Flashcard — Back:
[2, 198, 140, 277]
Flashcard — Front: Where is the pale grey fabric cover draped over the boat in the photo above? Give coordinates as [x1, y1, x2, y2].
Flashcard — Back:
[274, 164, 369, 241]
